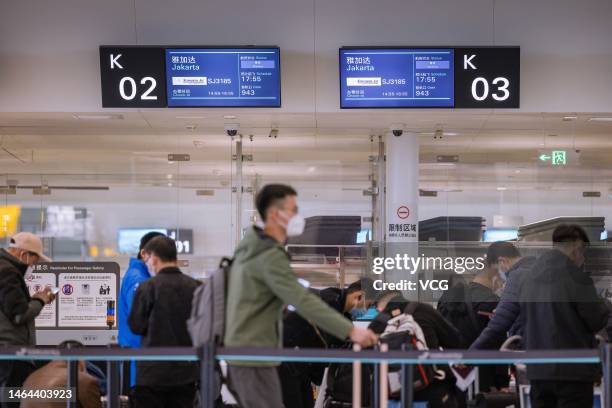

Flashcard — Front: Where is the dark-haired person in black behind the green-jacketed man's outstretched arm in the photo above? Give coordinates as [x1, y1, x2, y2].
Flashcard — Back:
[278, 278, 372, 408]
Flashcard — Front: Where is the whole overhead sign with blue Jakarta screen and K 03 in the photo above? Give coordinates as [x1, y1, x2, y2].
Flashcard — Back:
[339, 47, 520, 109]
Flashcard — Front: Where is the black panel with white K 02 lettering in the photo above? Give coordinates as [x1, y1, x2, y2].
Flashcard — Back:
[100, 46, 168, 108]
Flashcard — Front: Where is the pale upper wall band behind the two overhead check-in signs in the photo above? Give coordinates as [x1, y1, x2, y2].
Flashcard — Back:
[0, 0, 612, 112]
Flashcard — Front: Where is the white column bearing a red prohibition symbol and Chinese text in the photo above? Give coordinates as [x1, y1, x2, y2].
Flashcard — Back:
[384, 132, 419, 299]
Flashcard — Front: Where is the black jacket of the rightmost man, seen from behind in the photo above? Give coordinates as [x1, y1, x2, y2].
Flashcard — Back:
[520, 249, 608, 382]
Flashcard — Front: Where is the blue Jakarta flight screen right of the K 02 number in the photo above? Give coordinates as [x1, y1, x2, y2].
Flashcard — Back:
[166, 47, 281, 108]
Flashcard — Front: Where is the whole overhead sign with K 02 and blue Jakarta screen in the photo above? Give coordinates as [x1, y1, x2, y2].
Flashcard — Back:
[100, 46, 281, 108]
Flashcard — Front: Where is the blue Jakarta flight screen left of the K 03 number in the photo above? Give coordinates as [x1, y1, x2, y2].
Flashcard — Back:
[340, 48, 455, 108]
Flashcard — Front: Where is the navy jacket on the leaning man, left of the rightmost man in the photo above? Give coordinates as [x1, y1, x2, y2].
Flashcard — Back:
[470, 256, 536, 350]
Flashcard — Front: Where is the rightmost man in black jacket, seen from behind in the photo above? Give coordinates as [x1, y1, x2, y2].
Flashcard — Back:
[520, 225, 608, 408]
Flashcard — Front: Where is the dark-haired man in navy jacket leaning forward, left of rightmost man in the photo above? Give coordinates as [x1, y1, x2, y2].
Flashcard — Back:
[470, 241, 536, 350]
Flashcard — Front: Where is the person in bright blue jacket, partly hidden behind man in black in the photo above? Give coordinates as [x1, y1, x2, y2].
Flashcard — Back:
[117, 232, 164, 387]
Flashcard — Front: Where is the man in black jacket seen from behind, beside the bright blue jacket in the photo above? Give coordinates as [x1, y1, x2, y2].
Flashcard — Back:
[128, 236, 199, 408]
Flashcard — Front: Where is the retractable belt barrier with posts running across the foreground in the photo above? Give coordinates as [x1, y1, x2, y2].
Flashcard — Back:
[0, 344, 612, 408]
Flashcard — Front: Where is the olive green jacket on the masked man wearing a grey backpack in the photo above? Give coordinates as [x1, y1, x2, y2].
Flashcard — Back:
[225, 227, 353, 367]
